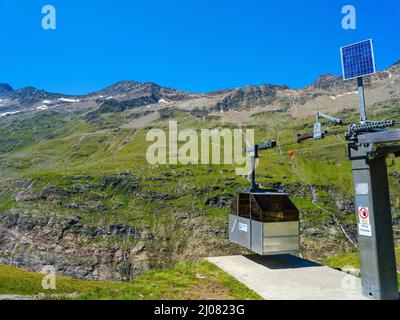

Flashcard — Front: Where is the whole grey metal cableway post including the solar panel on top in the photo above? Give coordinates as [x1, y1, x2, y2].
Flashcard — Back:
[340, 40, 400, 300]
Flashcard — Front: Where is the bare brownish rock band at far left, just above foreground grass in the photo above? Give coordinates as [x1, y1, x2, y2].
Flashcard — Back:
[0, 210, 150, 280]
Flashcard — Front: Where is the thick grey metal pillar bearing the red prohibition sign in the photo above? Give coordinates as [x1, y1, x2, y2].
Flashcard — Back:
[349, 147, 399, 300]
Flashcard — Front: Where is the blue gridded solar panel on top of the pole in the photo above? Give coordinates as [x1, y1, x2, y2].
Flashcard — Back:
[340, 39, 376, 80]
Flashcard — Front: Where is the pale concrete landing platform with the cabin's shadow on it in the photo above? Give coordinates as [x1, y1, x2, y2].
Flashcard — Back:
[207, 255, 367, 300]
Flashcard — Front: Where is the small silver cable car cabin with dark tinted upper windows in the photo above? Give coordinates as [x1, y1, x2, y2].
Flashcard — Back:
[229, 192, 300, 255]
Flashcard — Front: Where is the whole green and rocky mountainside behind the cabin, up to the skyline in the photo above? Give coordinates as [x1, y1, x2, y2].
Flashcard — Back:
[0, 64, 400, 298]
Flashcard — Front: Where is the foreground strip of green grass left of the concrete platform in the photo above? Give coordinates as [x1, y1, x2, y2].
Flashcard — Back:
[0, 261, 260, 300]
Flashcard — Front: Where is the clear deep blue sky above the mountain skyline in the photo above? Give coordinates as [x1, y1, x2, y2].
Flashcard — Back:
[0, 0, 400, 94]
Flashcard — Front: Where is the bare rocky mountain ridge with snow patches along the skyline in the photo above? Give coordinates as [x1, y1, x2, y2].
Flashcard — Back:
[0, 62, 400, 116]
